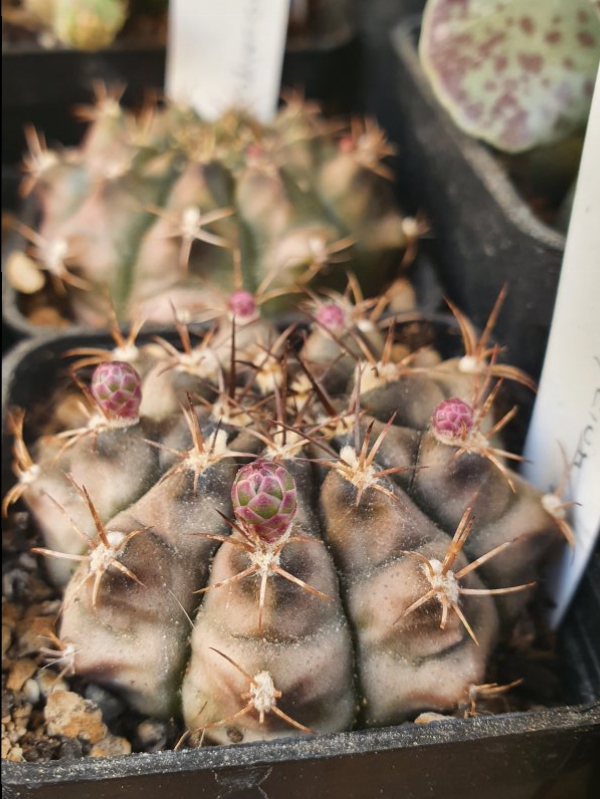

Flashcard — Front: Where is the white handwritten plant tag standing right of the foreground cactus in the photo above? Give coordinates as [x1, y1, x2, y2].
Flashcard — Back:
[522, 67, 600, 627]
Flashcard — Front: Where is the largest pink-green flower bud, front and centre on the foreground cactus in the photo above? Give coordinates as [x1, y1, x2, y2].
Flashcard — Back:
[231, 460, 297, 544]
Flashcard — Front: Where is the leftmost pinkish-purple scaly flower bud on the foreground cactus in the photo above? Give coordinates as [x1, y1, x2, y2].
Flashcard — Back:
[90, 361, 142, 421]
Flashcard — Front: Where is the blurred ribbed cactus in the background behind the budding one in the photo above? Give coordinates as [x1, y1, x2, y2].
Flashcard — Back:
[6, 92, 424, 327]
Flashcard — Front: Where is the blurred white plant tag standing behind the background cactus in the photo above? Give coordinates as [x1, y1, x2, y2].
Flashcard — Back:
[166, 0, 290, 122]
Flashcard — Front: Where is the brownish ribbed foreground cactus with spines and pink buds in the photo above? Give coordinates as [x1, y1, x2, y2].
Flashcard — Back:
[4, 291, 569, 756]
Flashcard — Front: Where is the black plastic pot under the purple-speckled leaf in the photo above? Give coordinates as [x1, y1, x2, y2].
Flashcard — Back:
[392, 16, 565, 378]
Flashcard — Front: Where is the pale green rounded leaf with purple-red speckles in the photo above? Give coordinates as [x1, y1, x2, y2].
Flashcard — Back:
[419, 0, 600, 152]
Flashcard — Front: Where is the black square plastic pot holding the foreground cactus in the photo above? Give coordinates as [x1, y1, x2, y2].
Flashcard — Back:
[2, 328, 600, 799]
